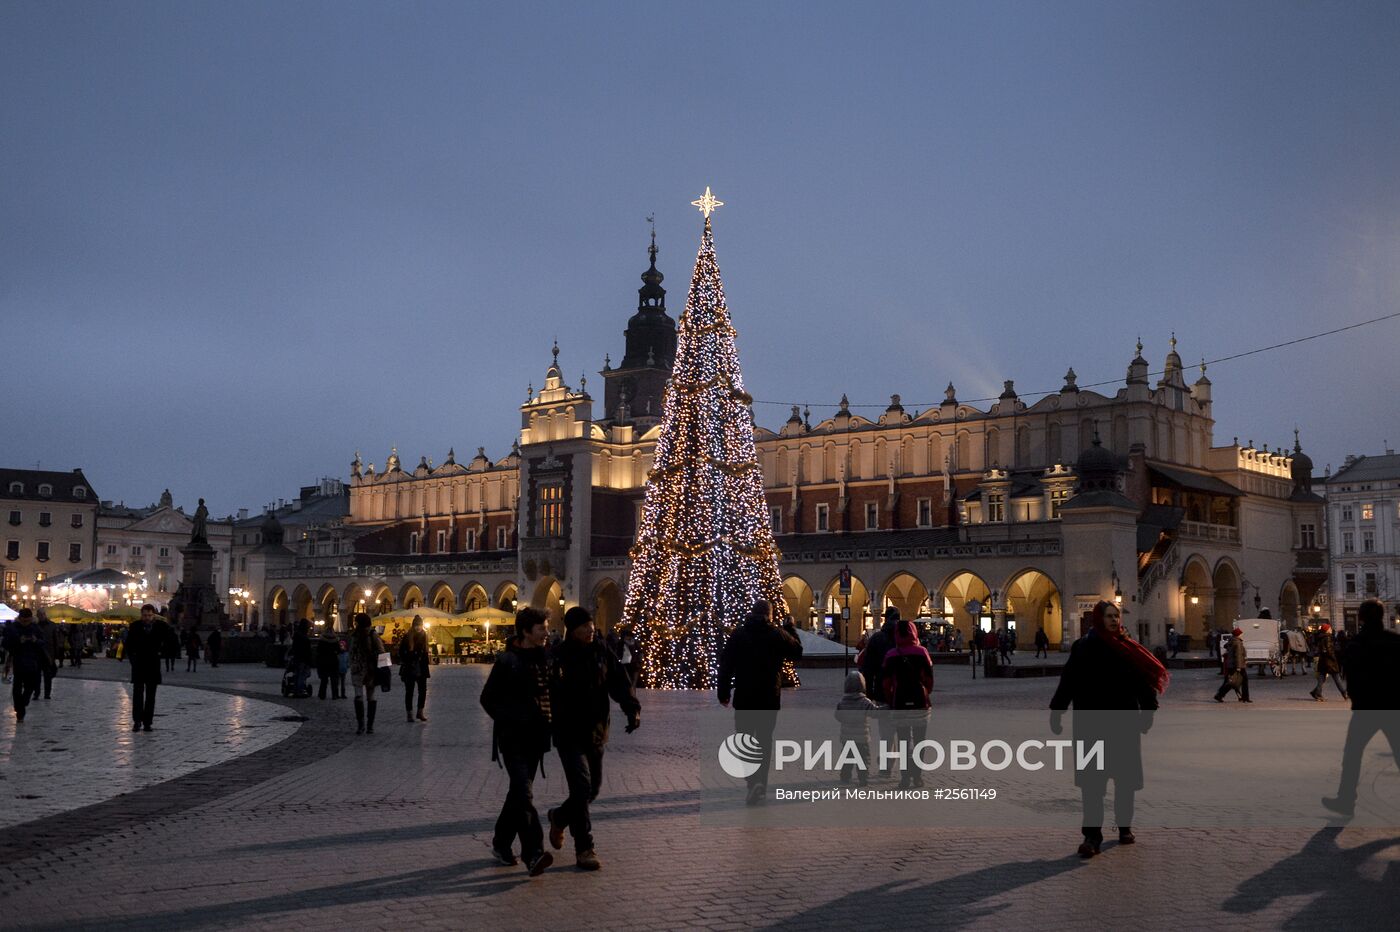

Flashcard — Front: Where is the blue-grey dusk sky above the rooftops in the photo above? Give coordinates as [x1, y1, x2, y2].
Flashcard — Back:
[0, 0, 1400, 515]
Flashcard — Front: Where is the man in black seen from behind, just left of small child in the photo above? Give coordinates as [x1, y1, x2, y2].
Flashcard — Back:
[720, 599, 806, 806]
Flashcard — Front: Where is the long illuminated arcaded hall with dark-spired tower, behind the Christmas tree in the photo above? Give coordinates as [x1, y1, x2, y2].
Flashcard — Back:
[260, 236, 1327, 645]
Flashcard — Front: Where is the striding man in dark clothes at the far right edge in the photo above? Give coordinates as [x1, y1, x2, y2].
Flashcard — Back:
[1322, 599, 1400, 816]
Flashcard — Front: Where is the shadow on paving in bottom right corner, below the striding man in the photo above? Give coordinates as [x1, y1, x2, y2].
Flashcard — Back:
[1222, 826, 1400, 929]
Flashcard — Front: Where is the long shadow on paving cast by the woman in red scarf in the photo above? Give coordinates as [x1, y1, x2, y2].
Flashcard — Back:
[766, 855, 1085, 932]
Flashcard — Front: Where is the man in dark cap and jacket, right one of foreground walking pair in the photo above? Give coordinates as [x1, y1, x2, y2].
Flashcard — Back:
[547, 606, 641, 870]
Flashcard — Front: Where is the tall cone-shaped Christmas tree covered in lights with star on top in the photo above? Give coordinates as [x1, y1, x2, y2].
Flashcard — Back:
[623, 188, 783, 689]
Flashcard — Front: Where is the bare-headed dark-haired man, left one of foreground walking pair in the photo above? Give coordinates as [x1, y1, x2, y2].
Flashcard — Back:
[482, 607, 554, 877]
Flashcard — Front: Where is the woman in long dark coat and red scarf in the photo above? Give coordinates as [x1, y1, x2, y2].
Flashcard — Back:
[1050, 602, 1170, 858]
